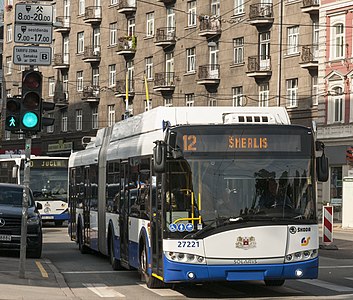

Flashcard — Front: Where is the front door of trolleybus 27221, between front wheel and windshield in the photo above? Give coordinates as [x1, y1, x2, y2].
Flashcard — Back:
[151, 174, 165, 276]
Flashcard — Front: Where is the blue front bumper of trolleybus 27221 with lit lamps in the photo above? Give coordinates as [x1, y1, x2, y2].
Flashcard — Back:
[163, 257, 319, 282]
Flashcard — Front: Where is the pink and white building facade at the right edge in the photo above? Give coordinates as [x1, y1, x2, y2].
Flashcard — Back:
[318, 0, 353, 219]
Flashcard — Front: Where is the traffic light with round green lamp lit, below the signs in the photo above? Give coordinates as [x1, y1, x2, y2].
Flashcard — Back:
[20, 70, 43, 133]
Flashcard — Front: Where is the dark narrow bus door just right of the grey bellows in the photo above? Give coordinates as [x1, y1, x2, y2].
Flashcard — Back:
[119, 162, 129, 267]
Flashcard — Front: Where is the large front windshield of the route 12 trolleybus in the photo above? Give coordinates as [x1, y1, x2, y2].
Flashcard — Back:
[166, 157, 316, 230]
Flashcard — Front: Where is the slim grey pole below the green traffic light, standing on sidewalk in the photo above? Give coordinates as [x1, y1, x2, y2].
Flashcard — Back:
[19, 132, 32, 278]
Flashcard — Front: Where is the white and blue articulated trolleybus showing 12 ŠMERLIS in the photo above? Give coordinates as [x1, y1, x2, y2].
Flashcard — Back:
[69, 107, 327, 288]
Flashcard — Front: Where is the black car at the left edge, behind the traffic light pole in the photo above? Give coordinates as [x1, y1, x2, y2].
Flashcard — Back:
[0, 183, 43, 258]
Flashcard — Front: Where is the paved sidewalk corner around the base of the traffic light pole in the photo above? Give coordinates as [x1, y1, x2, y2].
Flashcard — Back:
[0, 254, 78, 300]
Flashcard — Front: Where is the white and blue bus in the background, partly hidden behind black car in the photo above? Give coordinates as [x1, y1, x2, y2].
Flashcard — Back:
[0, 154, 69, 226]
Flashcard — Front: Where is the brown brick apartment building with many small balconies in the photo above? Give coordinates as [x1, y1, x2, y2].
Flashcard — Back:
[0, 0, 319, 155]
